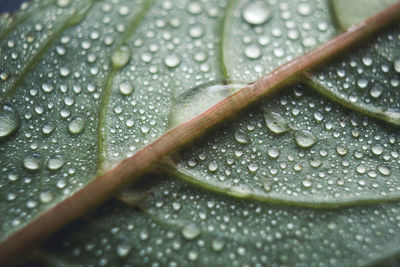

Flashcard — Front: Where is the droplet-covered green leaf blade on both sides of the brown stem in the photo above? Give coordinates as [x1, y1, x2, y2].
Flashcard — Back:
[0, 0, 400, 266]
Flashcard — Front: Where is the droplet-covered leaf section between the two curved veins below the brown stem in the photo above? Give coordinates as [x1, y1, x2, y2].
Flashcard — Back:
[179, 87, 400, 204]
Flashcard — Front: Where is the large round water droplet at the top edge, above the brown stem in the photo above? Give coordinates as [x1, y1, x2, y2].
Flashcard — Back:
[242, 1, 272, 25]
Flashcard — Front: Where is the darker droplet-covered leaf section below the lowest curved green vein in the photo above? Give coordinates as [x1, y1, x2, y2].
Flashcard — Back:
[48, 177, 400, 266]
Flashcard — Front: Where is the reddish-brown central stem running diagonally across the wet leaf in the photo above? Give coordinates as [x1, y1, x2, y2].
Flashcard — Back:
[0, 2, 400, 266]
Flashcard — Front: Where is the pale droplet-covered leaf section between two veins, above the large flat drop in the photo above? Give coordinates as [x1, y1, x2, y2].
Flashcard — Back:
[105, 1, 225, 161]
